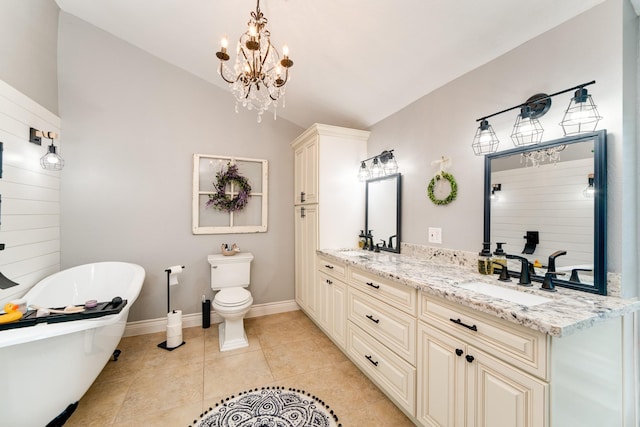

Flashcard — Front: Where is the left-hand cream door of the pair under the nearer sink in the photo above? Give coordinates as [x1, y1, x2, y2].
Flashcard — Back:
[416, 322, 464, 427]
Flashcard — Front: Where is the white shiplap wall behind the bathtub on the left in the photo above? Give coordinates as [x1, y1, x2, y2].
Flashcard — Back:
[0, 80, 64, 305]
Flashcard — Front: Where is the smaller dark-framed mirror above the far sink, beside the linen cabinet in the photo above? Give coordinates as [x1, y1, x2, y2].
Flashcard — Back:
[365, 173, 401, 253]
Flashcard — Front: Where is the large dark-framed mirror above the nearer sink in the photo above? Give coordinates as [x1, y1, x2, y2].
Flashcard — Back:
[484, 130, 607, 295]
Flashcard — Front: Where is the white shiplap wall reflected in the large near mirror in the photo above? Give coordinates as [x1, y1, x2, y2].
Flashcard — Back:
[491, 159, 594, 279]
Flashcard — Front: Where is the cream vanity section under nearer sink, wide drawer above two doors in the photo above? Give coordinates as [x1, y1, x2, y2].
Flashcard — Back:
[417, 294, 549, 427]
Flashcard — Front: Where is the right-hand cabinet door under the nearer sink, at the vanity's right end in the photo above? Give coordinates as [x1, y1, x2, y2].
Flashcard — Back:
[467, 346, 548, 427]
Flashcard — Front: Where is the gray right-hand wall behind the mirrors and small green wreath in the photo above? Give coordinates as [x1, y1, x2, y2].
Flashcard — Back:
[368, 0, 637, 295]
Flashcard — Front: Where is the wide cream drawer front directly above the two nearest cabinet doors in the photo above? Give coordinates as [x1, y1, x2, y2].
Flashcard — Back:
[420, 293, 548, 380]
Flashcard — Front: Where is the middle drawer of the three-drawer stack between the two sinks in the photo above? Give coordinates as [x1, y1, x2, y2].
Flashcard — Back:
[347, 287, 416, 365]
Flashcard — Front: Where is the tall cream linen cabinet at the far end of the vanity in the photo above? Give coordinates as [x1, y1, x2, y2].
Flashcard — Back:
[291, 123, 370, 319]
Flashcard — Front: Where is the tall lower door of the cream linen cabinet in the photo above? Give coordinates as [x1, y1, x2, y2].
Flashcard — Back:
[294, 205, 318, 318]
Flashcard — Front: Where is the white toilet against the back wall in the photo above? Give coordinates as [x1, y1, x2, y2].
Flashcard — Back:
[208, 252, 253, 351]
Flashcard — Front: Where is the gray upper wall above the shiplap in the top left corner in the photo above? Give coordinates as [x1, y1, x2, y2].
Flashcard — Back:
[0, 0, 59, 114]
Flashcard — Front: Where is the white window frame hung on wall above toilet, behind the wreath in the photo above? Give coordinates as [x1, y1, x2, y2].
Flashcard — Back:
[191, 154, 269, 234]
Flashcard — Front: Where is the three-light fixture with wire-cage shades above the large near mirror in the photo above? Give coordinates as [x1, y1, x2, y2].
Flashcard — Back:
[471, 80, 602, 156]
